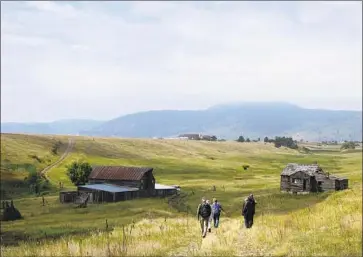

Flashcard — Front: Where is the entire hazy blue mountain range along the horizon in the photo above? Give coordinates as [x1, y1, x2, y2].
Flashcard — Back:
[1, 102, 362, 141]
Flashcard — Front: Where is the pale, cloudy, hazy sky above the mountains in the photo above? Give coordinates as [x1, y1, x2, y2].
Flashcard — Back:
[1, 1, 362, 122]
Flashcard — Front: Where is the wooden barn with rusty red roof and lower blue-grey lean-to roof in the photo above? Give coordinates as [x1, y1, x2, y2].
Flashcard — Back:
[60, 166, 178, 203]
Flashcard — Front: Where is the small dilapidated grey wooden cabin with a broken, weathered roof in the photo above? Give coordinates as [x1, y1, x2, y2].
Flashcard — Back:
[280, 163, 348, 193]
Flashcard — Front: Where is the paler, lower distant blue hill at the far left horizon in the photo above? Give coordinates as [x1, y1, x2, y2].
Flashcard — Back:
[1, 119, 104, 135]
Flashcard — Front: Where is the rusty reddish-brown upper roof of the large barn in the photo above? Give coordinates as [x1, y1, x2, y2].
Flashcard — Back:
[89, 166, 153, 180]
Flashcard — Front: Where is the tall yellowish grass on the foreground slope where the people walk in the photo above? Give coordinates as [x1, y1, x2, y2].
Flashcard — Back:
[2, 185, 362, 256]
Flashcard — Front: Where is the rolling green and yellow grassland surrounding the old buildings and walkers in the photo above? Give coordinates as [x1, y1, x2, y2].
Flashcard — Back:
[1, 134, 362, 256]
